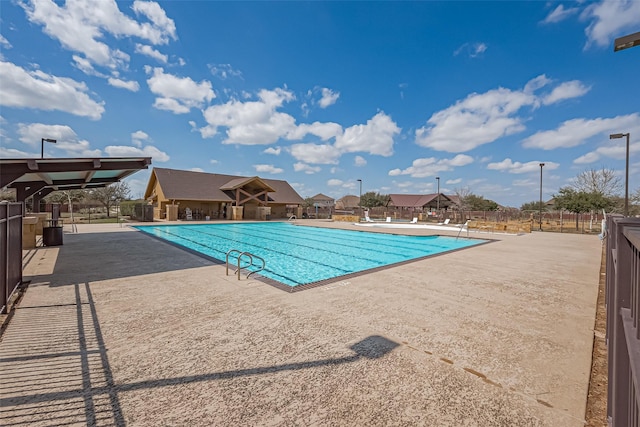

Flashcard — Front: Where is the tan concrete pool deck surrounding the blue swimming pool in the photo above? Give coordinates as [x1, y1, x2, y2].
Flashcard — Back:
[0, 220, 602, 427]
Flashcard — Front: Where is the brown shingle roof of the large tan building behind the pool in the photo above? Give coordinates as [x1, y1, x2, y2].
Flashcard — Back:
[145, 168, 304, 204]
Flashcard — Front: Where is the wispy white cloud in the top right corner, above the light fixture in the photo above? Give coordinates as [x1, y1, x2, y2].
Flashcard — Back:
[582, 0, 640, 47]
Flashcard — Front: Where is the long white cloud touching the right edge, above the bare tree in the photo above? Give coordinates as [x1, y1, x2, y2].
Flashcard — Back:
[522, 113, 640, 150]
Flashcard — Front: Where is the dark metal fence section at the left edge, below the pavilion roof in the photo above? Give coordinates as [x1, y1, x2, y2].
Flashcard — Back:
[0, 202, 24, 314]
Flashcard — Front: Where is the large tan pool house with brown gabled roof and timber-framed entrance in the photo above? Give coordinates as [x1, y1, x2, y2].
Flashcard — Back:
[144, 168, 304, 221]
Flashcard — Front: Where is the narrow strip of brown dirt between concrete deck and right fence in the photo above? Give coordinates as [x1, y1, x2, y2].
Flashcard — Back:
[586, 247, 608, 427]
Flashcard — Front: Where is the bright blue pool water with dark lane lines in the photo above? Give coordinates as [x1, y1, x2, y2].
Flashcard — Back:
[135, 222, 486, 287]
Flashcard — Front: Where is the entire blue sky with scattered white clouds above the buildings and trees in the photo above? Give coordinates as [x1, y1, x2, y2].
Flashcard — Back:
[0, 0, 640, 207]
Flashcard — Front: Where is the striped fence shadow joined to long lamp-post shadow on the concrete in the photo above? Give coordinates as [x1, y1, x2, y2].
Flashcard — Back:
[0, 283, 399, 426]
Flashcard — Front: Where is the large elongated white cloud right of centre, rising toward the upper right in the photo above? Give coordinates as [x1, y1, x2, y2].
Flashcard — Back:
[415, 75, 589, 153]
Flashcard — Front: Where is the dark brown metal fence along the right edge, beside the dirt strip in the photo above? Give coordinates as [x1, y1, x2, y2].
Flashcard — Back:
[606, 216, 640, 427]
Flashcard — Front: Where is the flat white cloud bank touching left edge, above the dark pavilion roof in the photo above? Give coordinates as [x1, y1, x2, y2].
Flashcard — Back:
[0, 62, 104, 120]
